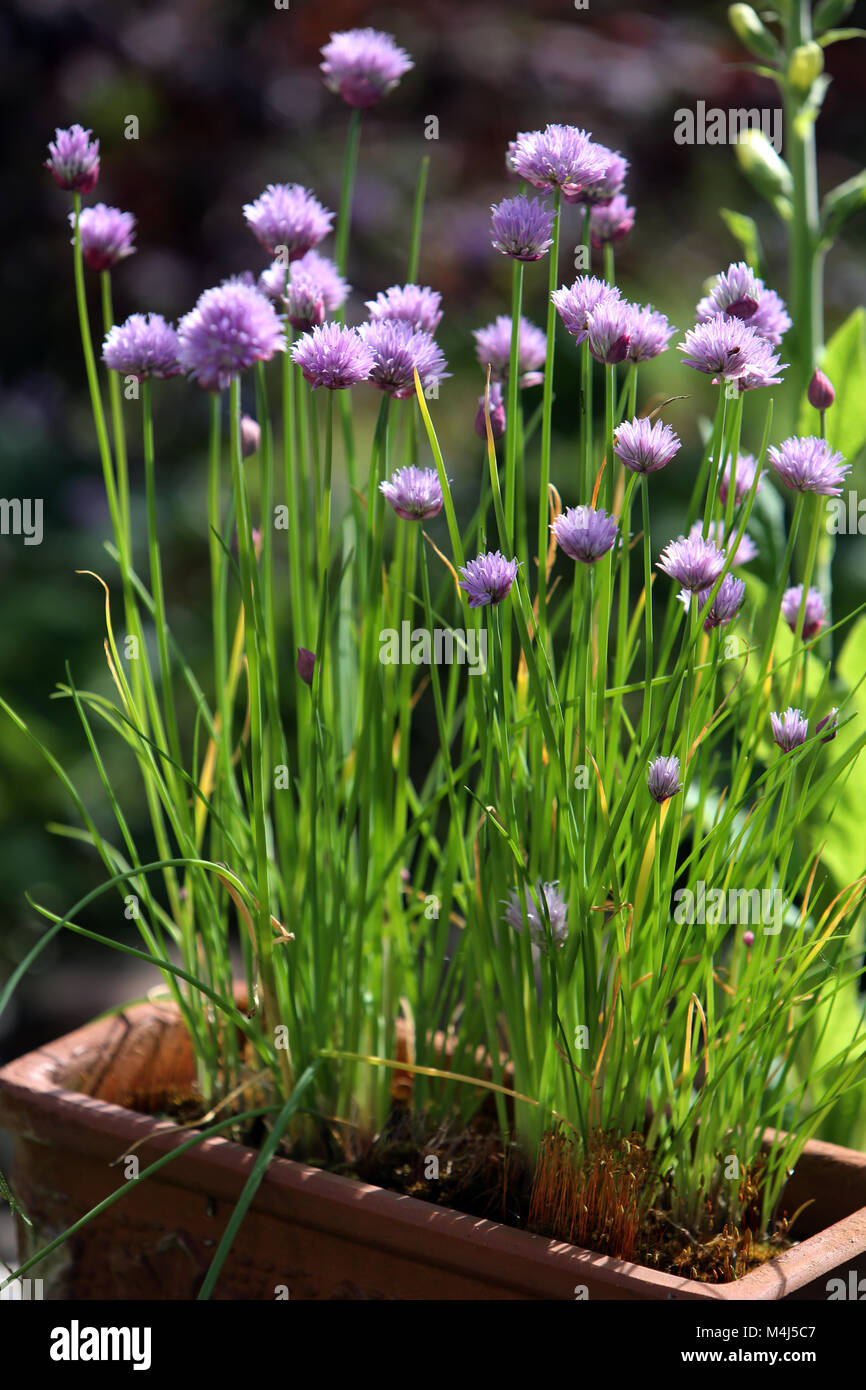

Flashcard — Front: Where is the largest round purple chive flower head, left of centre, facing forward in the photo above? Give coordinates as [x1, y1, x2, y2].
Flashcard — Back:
[178, 279, 285, 391]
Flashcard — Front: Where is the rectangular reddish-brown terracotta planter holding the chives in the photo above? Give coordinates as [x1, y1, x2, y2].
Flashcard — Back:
[0, 1005, 866, 1301]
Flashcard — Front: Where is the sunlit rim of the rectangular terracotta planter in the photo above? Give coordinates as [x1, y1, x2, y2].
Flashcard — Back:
[0, 1004, 866, 1301]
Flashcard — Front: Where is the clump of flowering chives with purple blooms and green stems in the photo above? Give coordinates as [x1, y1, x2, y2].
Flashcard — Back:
[3, 6, 866, 1273]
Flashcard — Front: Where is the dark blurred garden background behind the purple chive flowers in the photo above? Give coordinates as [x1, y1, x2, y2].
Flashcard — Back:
[0, 0, 866, 1084]
